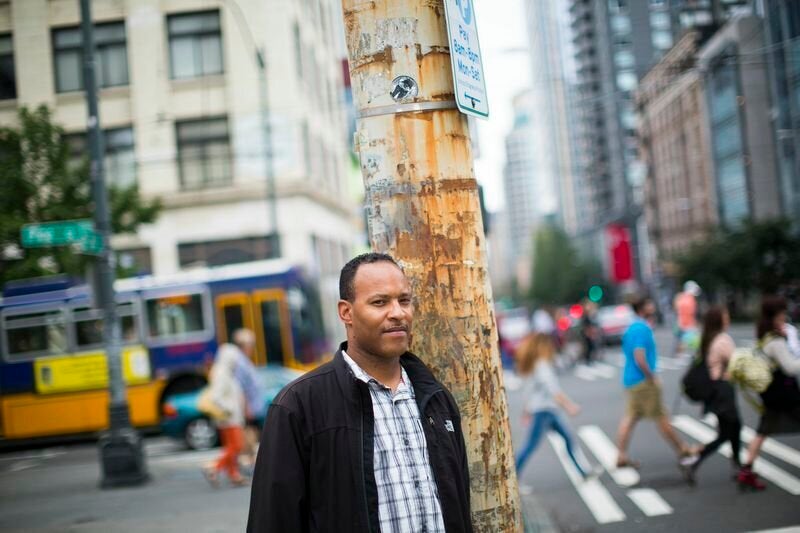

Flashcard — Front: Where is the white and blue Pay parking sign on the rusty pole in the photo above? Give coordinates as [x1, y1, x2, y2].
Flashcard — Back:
[444, 0, 489, 118]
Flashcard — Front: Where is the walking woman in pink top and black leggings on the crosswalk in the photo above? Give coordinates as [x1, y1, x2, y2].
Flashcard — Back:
[681, 306, 742, 484]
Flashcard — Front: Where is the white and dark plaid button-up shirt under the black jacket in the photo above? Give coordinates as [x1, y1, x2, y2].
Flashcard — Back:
[342, 352, 445, 533]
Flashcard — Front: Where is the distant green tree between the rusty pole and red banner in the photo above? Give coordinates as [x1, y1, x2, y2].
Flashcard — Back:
[530, 225, 603, 305]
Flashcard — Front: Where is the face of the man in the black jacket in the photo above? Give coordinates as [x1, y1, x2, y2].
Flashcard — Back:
[339, 261, 414, 358]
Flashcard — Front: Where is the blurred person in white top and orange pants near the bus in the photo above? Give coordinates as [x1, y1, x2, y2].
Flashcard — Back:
[203, 344, 247, 487]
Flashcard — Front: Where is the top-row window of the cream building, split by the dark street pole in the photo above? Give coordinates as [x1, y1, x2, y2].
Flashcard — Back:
[53, 22, 128, 93]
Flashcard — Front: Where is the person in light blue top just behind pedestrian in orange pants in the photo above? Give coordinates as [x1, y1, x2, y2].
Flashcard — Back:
[233, 328, 266, 467]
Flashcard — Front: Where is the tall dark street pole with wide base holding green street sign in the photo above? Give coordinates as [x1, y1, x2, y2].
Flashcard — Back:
[81, 0, 147, 488]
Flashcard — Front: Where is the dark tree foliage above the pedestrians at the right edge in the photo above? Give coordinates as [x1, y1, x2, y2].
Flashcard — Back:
[675, 218, 800, 294]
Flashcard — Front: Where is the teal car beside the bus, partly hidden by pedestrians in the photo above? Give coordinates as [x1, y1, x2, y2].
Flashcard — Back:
[161, 365, 302, 450]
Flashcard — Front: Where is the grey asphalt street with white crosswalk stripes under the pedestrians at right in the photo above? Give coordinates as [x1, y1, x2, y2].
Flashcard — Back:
[509, 326, 800, 533]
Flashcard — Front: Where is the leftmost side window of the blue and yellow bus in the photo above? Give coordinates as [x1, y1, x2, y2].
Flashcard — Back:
[3, 309, 68, 361]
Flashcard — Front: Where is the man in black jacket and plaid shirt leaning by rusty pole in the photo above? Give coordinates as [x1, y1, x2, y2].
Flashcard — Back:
[247, 253, 472, 533]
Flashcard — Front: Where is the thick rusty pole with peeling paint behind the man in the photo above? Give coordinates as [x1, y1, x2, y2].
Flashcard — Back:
[342, 0, 522, 533]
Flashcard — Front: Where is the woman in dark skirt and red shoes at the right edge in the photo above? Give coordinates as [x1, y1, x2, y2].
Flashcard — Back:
[739, 296, 800, 489]
